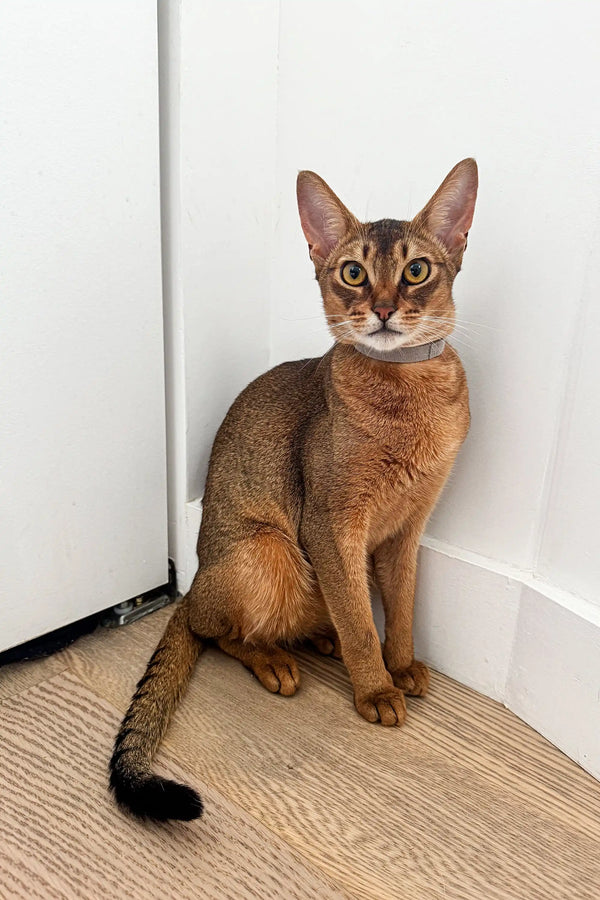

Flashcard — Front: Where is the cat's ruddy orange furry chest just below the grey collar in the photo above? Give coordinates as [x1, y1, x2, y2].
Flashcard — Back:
[333, 347, 469, 544]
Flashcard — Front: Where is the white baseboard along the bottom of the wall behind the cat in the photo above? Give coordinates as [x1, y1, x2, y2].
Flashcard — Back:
[183, 499, 600, 779]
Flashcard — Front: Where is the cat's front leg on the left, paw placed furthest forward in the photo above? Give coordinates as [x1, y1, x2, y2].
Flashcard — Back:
[302, 522, 406, 725]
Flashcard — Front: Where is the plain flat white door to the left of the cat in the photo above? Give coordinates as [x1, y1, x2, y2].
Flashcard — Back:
[0, 0, 168, 650]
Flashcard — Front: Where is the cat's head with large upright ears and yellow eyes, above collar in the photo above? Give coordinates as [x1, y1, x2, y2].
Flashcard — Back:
[298, 159, 477, 351]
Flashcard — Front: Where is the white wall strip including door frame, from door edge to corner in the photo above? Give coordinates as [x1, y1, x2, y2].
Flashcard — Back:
[159, 0, 279, 588]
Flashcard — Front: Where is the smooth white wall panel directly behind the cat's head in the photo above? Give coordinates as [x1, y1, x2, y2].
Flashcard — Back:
[271, 0, 600, 569]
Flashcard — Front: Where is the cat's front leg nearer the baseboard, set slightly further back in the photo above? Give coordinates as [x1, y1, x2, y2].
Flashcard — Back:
[373, 518, 429, 697]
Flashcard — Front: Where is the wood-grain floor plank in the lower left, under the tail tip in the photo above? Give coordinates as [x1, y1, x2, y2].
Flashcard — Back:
[0, 672, 345, 900]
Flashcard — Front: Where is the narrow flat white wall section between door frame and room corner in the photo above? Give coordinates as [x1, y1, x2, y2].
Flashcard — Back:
[181, 0, 278, 497]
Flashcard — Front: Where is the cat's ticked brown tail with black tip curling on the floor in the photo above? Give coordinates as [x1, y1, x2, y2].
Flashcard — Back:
[109, 601, 202, 821]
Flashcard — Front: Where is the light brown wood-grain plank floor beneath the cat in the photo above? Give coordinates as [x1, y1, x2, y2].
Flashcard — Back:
[0, 610, 600, 900]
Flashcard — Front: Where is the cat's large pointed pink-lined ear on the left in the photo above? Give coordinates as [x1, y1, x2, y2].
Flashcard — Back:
[296, 172, 357, 269]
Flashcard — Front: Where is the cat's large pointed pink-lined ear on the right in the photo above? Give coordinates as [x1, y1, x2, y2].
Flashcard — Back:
[413, 159, 477, 266]
